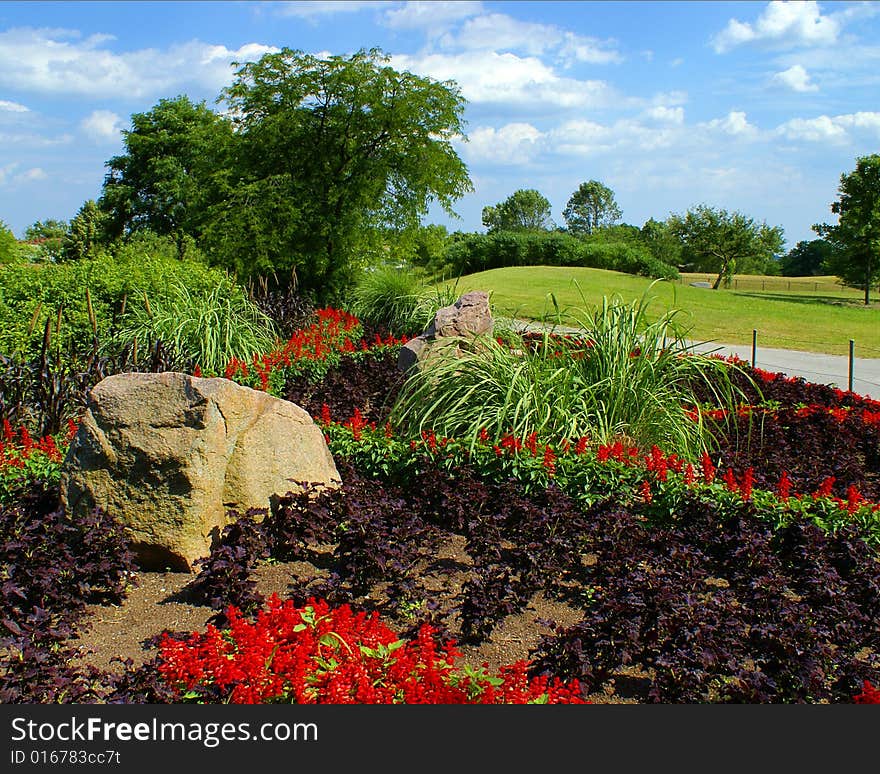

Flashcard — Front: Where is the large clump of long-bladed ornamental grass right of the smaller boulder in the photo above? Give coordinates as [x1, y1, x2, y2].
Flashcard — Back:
[391, 298, 738, 456]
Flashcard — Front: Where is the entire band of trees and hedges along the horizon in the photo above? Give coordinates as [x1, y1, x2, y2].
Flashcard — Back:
[0, 42, 880, 303]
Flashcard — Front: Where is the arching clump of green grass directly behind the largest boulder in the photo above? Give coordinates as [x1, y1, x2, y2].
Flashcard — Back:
[117, 277, 276, 374]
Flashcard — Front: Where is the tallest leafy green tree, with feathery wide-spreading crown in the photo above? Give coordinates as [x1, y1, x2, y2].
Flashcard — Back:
[213, 48, 471, 299]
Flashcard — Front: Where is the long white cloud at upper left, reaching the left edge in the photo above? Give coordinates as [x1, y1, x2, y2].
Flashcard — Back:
[0, 27, 278, 98]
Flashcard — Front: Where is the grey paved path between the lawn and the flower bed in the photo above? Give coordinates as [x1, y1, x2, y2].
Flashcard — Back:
[506, 320, 880, 400]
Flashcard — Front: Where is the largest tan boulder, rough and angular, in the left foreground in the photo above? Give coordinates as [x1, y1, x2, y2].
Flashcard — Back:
[61, 372, 340, 571]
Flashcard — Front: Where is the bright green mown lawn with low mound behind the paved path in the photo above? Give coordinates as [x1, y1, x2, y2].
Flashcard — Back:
[446, 266, 880, 358]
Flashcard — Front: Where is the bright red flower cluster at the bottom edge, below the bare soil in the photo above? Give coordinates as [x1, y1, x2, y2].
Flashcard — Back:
[159, 595, 585, 704]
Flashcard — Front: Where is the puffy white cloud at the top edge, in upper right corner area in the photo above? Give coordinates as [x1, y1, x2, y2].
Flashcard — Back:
[712, 0, 841, 54]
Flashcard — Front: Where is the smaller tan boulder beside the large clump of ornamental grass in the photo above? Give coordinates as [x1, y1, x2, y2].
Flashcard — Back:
[397, 290, 493, 372]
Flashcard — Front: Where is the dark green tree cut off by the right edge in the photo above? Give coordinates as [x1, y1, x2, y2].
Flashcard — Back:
[813, 153, 880, 305]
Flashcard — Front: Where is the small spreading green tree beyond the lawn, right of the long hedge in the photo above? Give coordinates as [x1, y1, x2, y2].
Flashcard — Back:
[667, 204, 785, 290]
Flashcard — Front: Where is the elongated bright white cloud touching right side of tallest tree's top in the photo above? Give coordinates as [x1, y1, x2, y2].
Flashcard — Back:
[391, 51, 615, 110]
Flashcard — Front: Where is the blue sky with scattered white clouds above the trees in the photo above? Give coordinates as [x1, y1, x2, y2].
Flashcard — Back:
[0, 0, 880, 247]
